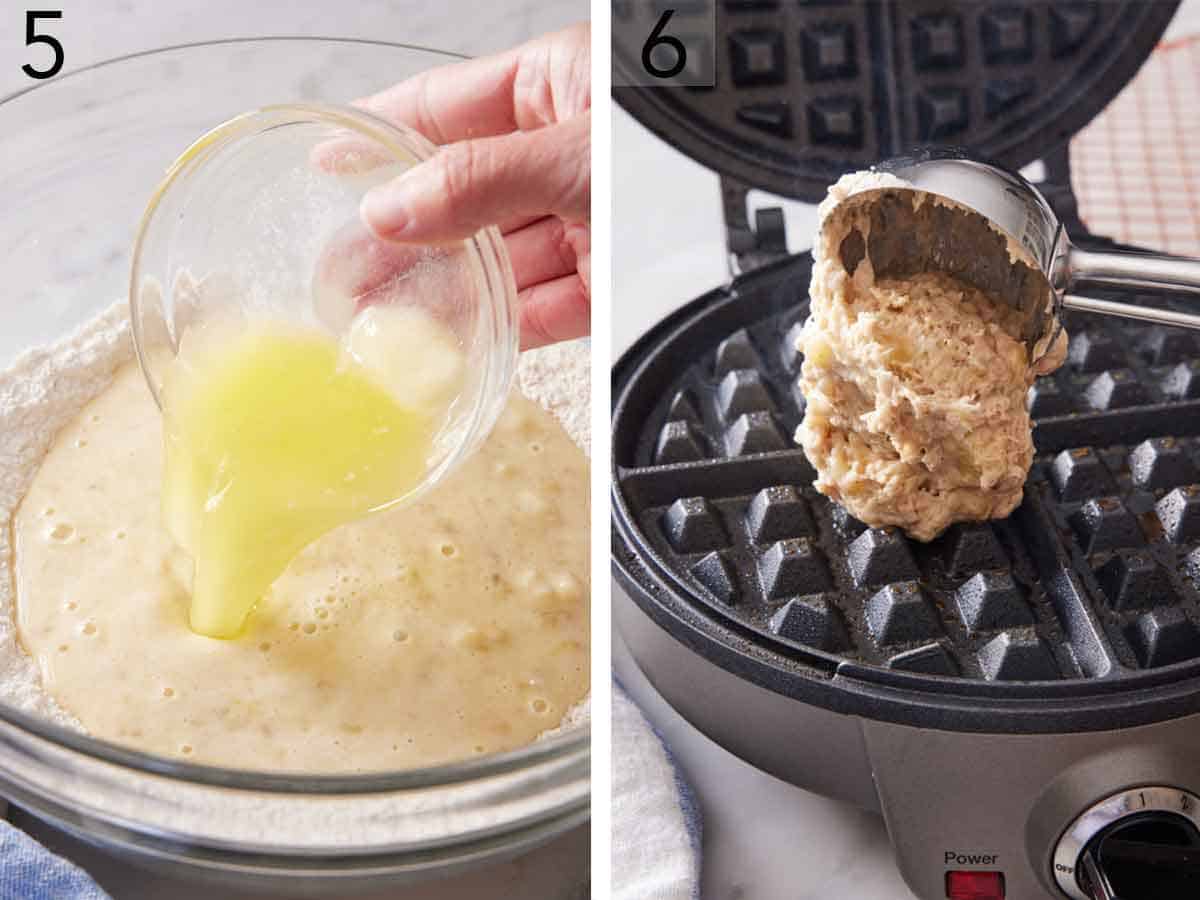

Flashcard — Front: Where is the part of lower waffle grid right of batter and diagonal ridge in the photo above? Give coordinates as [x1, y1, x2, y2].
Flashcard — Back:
[1028, 317, 1200, 668]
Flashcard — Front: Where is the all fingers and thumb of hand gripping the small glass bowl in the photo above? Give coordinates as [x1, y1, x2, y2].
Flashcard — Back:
[331, 25, 592, 348]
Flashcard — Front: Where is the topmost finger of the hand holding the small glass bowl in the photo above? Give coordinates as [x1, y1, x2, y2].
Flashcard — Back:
[356, 24, 592, 144]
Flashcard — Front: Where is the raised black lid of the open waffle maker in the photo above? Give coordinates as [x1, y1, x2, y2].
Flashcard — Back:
[613, 0, 1178, 203]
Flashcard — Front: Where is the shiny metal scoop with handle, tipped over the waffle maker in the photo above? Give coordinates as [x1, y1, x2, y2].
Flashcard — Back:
[839, 150, 1200, 361]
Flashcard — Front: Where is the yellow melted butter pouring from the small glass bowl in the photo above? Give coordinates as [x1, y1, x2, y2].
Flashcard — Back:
[162, 317, 457, 637]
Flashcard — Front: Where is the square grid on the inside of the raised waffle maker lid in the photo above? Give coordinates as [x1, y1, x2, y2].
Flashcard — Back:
[618, 0, 1152, 199]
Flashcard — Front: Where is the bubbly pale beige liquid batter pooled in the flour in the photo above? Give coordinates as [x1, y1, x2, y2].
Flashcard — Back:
[13, 364, 588, 772]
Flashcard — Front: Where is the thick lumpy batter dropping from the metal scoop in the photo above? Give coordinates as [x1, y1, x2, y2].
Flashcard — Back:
[796, 173, 1067, 541]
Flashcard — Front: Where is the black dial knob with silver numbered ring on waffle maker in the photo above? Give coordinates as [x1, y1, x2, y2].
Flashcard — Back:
[1054, 787, 1200, 900]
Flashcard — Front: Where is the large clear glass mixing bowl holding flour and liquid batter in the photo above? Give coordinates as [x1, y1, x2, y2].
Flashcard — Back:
[0, 38, 590, 894]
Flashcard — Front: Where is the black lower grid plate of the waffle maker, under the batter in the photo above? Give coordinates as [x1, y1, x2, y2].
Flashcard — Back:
[618, 282, 1200, 680]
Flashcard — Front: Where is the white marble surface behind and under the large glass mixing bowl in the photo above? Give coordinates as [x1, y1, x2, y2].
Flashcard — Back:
[0, 0, 589, 900]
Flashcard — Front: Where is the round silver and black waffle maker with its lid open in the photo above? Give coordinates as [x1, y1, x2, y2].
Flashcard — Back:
[612, 0, 1200, 900]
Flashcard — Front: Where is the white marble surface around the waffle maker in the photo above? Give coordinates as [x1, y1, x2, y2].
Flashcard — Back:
[612, 0, 1200, 900]
